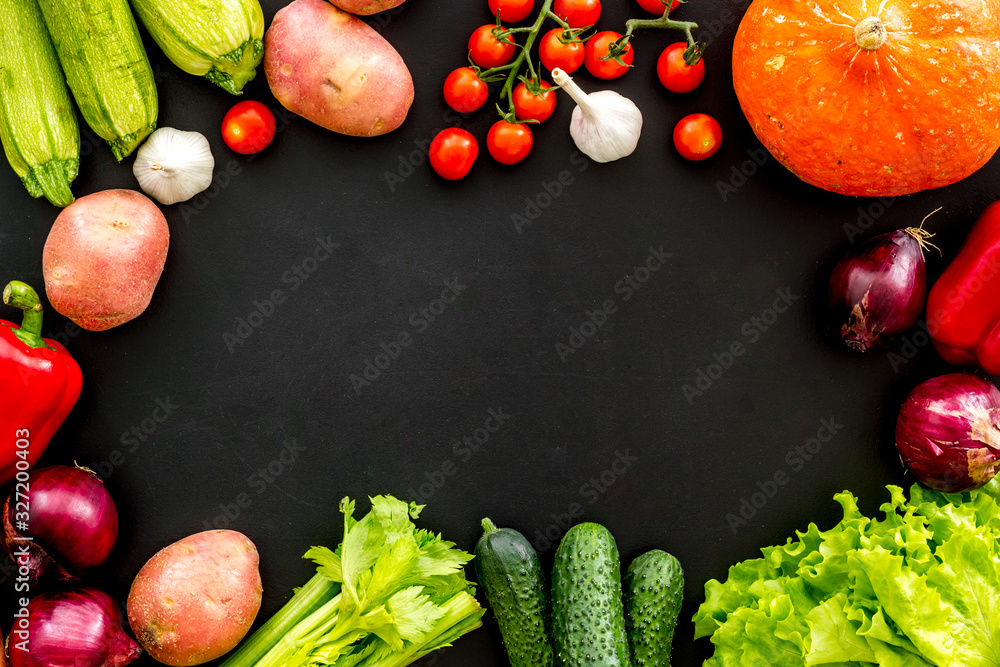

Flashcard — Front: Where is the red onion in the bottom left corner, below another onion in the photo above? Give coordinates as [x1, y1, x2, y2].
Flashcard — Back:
[7, 588, 142, 667]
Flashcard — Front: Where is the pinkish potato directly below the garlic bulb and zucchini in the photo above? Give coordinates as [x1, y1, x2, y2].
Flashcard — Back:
[42, 190, 170, 331]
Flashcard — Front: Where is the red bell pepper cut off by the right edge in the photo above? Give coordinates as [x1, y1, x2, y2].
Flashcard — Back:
[927, 202, 1000, 375]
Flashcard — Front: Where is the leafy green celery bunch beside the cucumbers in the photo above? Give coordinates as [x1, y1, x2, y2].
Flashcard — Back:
[221, 496, 484, 667]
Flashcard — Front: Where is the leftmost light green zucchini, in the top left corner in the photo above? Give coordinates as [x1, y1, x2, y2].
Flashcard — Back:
[0, 0, 80, 206]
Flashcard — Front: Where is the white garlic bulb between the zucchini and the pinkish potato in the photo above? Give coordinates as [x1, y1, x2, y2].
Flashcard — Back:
[132, 127, 215, 204]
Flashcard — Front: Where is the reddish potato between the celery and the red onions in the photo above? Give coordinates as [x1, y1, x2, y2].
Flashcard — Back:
[127, 530, 262, 667]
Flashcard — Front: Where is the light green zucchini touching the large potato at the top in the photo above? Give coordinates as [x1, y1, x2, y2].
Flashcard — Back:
[132, 0, 264, 95]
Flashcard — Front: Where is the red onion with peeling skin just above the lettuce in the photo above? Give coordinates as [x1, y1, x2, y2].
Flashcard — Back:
[896, 373, 1000, 493]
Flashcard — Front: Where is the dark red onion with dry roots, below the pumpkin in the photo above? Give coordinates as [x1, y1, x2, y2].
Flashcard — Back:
[828, 229, 927, 352]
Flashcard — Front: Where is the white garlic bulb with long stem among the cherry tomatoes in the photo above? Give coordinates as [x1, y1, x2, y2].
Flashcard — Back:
[552, 67, 642, 162]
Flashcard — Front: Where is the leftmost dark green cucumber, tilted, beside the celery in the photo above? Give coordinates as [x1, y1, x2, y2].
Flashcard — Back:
[473, 519, 554, 667]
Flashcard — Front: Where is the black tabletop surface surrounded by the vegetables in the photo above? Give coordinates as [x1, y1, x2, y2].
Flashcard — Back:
[0, 0, 1000, 666]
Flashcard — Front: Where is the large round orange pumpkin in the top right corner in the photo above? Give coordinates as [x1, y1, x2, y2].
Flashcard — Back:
[733, 0, 1000, 196]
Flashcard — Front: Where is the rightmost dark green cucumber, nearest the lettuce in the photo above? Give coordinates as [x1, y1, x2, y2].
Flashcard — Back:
[625, 549, 684, 667]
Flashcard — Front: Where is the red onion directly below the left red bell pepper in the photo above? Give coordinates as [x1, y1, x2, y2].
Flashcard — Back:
[3, 466, 118, 585]
